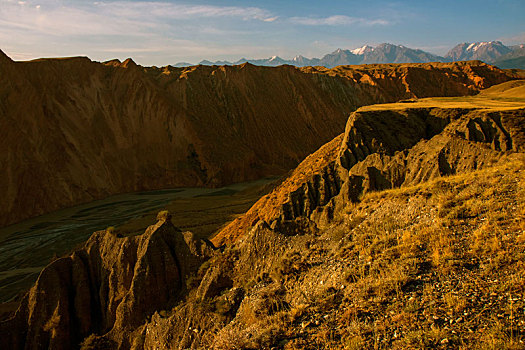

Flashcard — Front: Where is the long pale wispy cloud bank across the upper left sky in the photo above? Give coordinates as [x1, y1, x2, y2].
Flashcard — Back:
[0, 0, 277, 36]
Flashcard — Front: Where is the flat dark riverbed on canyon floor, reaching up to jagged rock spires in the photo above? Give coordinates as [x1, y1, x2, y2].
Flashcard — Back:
[0, 178, 275, 302]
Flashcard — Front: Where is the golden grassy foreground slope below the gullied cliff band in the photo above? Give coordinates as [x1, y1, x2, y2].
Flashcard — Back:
[152, 154, 525, 349]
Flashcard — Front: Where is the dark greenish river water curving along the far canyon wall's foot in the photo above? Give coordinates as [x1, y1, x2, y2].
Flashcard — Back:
[0, 179, 274, 302]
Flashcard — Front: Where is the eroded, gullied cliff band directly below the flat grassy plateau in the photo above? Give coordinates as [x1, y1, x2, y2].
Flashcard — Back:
[212, 107, 525, 246]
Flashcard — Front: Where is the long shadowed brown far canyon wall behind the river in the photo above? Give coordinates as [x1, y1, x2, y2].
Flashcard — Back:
[0, 50, 511, 226]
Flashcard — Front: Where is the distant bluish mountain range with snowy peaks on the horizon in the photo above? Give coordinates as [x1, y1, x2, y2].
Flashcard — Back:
[175, 41, 525, 68]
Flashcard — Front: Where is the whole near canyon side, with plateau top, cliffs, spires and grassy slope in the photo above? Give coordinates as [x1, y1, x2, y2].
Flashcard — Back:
[0, 83, 525, 349]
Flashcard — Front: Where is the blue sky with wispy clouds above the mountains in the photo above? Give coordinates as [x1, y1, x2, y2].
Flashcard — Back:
[0, 0, 525, 66]
